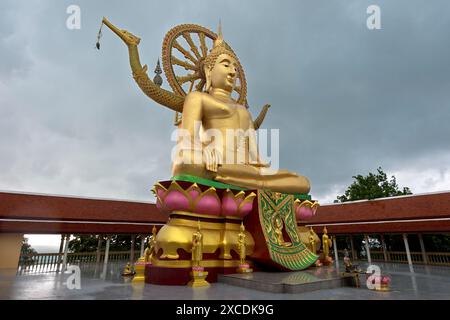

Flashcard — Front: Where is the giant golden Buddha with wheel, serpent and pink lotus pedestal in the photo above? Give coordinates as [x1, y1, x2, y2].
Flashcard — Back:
[97, 18, 316, 278]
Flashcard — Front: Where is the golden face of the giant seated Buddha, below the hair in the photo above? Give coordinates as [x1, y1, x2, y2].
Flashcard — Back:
[207, 53, 237, 92]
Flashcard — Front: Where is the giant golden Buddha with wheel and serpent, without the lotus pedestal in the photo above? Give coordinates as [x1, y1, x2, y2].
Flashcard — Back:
[102, 18, 310, 194]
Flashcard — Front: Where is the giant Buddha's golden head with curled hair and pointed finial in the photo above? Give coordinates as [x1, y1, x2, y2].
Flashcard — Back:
[203, 29, 239, 93]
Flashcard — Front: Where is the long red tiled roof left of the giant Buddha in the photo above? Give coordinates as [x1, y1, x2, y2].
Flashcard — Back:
[0, 192, 167, 233]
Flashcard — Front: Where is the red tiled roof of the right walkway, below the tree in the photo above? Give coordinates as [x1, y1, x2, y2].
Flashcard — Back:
[303, 192, 450, 233]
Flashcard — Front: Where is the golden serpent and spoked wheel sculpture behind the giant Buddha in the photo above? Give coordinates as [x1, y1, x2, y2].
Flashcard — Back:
[97, 18, 270, 129]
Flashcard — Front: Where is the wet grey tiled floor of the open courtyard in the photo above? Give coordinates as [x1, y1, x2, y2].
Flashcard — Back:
[0, 263, 450, 300]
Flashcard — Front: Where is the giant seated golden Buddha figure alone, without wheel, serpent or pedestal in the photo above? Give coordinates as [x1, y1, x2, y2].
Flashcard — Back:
[172, 32, 310, 194]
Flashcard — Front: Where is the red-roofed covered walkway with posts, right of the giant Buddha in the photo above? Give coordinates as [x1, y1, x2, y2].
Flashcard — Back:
[301, 192, 450, 272]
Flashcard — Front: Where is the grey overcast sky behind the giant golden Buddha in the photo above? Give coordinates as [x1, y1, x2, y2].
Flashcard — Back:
[0, 0, 450, 216]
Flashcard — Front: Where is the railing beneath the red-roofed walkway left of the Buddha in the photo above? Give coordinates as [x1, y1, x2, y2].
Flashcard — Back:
[17, 251, 139, 274]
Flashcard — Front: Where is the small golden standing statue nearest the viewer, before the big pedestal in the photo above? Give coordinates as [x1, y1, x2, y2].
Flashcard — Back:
[188, 220, 209, 287]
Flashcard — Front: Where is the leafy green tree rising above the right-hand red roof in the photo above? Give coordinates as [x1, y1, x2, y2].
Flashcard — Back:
[334, 167, 412, 203]
